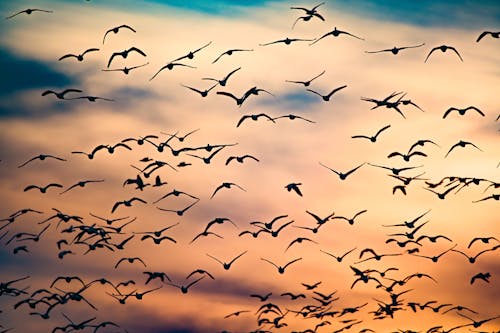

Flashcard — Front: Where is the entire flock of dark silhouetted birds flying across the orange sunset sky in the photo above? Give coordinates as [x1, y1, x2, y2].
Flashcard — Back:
[0, 2, 500, 333]
